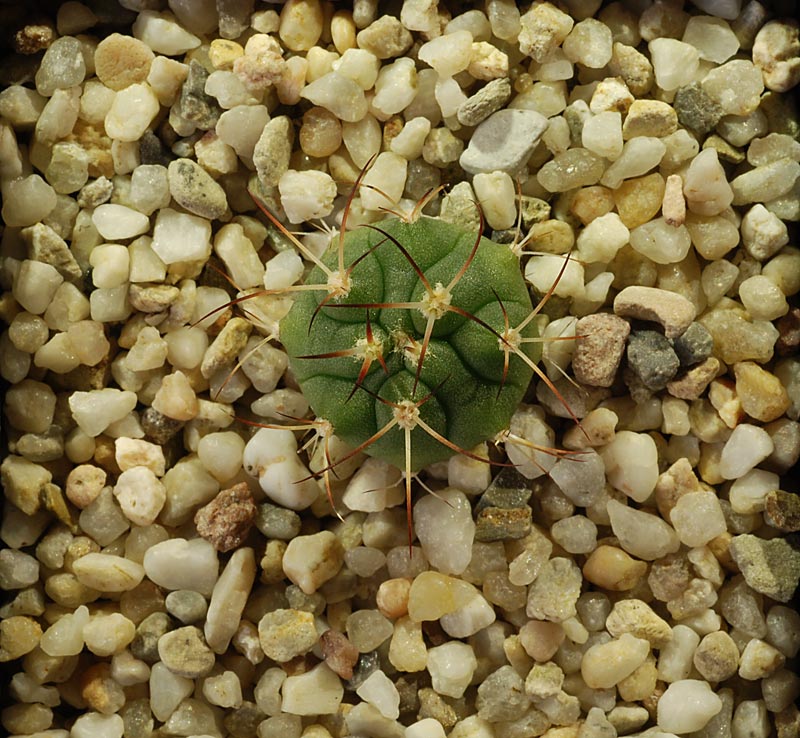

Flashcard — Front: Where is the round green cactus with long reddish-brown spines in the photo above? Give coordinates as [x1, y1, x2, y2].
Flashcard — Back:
[280, 216, 541, 474]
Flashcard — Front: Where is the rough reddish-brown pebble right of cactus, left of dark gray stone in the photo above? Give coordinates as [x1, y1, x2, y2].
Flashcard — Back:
[572, 313, 631, 387]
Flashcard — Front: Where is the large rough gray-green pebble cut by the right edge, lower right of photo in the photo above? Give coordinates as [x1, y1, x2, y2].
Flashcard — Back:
[729, 534, 800, 602]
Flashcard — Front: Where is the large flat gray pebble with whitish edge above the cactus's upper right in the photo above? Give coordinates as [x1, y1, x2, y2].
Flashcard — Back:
[460, 109, 547, 174]
